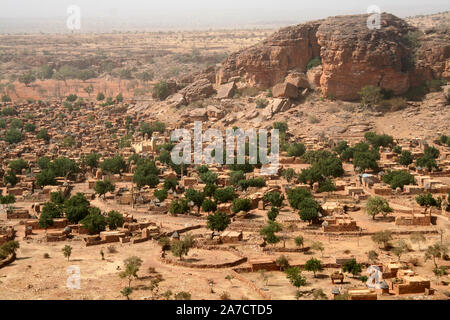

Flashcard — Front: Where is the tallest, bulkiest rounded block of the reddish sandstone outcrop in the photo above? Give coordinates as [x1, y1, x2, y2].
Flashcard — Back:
[317, 14, 412, 100]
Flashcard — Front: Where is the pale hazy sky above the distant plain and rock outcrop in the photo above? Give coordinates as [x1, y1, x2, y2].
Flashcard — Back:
[0, 0, 450, 32]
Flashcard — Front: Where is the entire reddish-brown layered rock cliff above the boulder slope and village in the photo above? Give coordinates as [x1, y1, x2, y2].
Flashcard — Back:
[216, 13, 449, 100]
